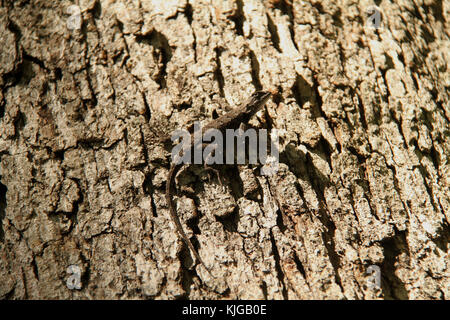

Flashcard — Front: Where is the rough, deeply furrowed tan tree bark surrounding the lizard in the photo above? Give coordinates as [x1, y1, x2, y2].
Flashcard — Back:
[0, 0, 450, 299]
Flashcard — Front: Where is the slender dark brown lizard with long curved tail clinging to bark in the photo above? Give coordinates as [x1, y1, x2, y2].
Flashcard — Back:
[166, 91, 271, 274]
